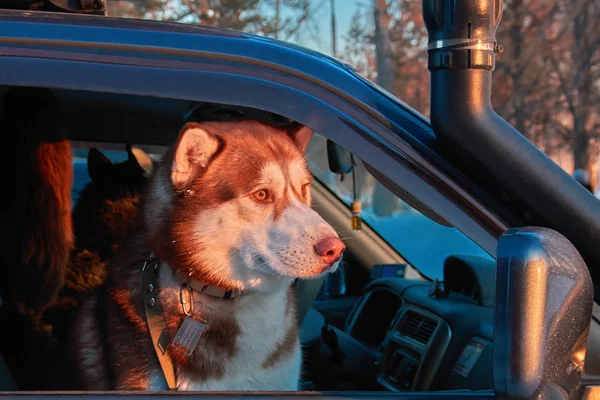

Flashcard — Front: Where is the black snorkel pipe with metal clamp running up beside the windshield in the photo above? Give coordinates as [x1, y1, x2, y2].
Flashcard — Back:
[423, 0, 600, 285]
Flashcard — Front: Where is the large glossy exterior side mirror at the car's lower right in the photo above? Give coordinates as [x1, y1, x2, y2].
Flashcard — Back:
[493, 227, 594, 399]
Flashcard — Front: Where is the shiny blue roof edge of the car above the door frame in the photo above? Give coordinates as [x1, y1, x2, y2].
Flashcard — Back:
[0, 9, 429, 124]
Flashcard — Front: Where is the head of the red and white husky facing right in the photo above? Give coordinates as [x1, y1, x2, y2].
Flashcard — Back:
[145, 121, 345, 291]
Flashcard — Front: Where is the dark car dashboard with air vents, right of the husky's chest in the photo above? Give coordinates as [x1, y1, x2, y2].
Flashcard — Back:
[308, 256, 495, 391]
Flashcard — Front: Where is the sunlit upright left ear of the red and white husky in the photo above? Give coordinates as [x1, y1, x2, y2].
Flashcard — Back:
[171, 122, 220, 190]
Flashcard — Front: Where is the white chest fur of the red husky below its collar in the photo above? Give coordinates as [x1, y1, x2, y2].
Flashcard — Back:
[160, 271, 302, 391]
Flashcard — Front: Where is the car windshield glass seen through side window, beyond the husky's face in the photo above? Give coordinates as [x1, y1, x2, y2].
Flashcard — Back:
[306, 134, 492, 280]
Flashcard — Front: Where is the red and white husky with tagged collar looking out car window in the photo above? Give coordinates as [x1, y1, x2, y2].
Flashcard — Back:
[72, 121, 345, 391]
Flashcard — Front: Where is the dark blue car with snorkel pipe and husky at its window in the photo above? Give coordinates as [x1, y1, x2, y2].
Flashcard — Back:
[0, 1, 600, 399]
